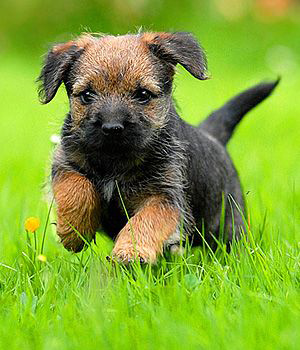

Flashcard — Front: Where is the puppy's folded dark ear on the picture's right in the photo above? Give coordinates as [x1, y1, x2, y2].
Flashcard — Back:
[142, 32, 208, 80]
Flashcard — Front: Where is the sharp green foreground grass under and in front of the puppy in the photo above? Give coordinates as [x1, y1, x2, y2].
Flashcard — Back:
[0, 196, 300, 349]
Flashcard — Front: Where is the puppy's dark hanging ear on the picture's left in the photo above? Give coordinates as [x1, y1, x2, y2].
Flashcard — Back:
[37, 36, 92, 103]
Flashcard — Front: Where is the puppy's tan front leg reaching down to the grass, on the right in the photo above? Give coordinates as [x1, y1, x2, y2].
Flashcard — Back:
[113, 197, 179, 263]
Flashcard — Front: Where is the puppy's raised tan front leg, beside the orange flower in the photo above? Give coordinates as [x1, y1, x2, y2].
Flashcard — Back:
[52, 171, 100, 252]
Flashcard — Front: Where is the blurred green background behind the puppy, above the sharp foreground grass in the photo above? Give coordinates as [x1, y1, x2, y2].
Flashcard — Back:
[0, 0, 300, 252]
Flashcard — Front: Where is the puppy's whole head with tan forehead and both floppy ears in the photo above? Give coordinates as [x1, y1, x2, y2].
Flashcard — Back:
[39, 32, 207, 155]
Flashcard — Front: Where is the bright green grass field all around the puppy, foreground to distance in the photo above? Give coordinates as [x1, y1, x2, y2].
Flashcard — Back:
[0, 18, 300, 350]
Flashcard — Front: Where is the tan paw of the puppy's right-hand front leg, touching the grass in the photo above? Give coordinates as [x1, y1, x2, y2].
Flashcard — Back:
[112, 244, 157, 264]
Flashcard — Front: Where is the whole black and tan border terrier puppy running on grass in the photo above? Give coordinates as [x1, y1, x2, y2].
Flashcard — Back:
[39, 32, 277, 263]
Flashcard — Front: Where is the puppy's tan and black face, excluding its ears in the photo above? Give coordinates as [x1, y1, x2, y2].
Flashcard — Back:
[70, 36, 173, 155]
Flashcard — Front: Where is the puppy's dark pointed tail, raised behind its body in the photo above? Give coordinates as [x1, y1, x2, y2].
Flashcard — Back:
[199, 78, 280, 145]
